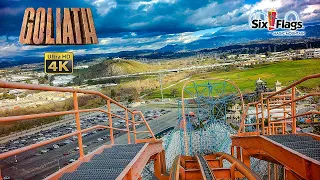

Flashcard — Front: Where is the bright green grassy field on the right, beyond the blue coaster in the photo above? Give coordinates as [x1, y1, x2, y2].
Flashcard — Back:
[147, 59, 320, 99]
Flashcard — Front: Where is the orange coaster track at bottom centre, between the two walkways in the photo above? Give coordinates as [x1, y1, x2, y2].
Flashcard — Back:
[169, 153, 260, 180]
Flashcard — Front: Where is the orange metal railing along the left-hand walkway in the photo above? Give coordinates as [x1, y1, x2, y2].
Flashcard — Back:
[0, 81, 156, 159]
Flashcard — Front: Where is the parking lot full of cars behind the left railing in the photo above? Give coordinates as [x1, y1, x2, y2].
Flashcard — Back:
[0, 108, 176, 179]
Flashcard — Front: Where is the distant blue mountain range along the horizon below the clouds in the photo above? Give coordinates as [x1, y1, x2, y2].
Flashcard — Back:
[0, 23, 320, 68]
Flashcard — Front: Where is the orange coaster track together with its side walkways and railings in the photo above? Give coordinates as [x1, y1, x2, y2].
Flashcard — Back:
[0, 74, 320, 180]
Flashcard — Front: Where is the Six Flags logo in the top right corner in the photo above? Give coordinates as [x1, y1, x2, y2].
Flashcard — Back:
[249, 10, 305, 36]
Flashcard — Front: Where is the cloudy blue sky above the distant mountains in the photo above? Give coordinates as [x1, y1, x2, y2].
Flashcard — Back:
[0, 0, 320, 60]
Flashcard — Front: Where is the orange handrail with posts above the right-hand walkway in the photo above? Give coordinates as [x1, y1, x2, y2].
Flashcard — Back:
[238, 74, 320, 135]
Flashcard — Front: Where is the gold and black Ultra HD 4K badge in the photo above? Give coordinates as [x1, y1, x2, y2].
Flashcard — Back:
[44, 52, 73, 74]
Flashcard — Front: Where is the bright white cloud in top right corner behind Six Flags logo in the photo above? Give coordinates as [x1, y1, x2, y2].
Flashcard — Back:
[187, 0, 320, 28]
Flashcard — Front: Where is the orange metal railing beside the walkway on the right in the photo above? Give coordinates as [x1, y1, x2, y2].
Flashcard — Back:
[238, 74, 320, 135]
